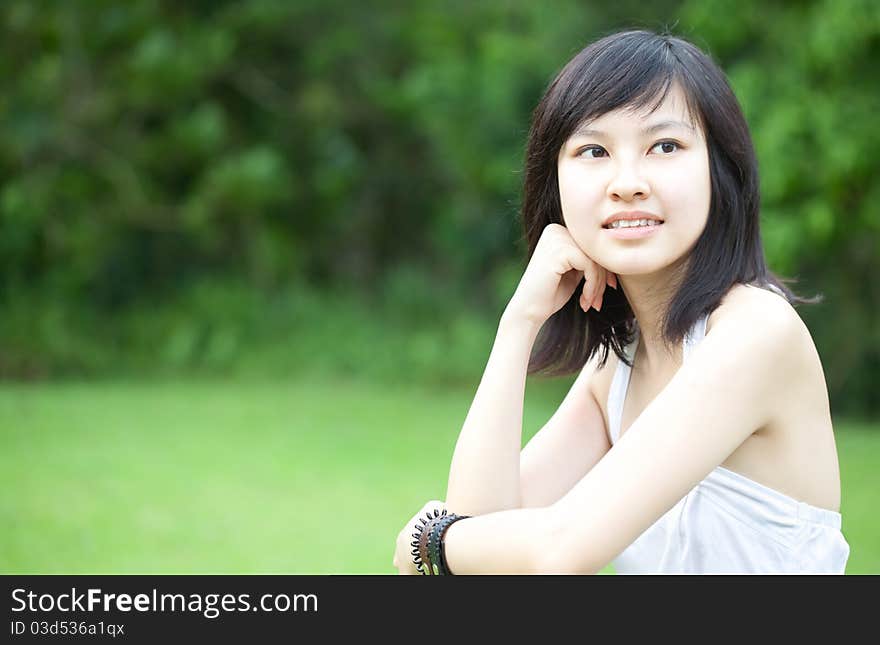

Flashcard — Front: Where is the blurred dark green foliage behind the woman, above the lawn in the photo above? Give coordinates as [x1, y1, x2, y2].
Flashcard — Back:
[0, 0, 880, 414]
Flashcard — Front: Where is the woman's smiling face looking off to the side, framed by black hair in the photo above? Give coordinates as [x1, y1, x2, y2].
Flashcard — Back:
[558, 86, 711, 276]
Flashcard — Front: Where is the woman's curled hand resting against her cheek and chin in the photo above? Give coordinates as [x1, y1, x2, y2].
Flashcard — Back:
[504, 224, 617, 325]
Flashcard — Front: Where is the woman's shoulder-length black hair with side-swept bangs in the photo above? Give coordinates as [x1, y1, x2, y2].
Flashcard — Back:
[521, 30, 821, 376]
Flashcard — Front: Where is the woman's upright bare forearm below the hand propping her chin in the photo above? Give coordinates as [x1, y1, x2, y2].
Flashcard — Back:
[446, 316, 539, 515]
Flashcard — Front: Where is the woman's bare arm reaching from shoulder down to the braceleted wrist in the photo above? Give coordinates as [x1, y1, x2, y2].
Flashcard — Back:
[446, 296, 801, 574]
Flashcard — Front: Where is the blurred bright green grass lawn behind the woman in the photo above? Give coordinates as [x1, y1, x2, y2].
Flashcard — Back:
[0, 380, 880, 574]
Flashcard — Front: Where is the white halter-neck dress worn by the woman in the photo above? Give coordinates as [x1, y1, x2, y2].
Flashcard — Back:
[608, 315, 850, 574]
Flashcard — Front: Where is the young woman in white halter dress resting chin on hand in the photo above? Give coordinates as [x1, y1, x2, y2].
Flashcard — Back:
[393, 31, 849, 574]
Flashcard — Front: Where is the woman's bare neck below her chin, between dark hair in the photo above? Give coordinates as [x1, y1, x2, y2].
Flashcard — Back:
[618, 260, 683, 372]
